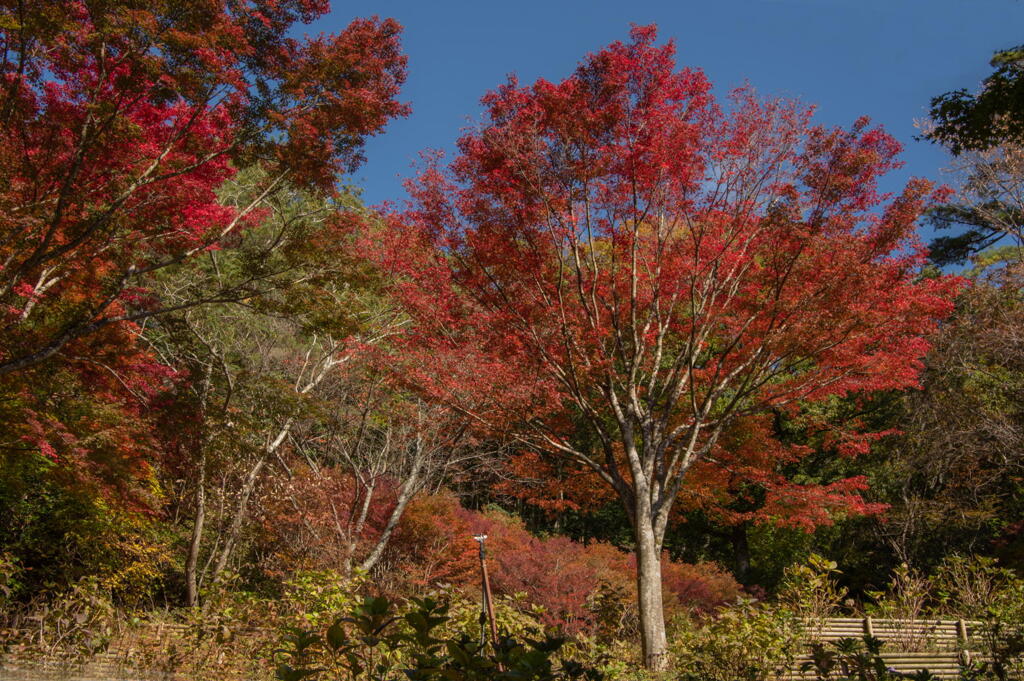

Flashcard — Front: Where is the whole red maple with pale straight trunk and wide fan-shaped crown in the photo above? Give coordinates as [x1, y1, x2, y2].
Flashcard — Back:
[375, 27, 959, 669]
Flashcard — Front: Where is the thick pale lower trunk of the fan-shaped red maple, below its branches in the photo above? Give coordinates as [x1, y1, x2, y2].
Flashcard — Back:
[636, 513, 669, 672]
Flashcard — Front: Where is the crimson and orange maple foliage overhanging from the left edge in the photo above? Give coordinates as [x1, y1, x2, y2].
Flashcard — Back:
[0, 0, 408, 497]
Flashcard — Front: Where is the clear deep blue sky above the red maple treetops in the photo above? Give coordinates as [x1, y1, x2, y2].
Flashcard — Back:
[311, 0, 1024, 223]
